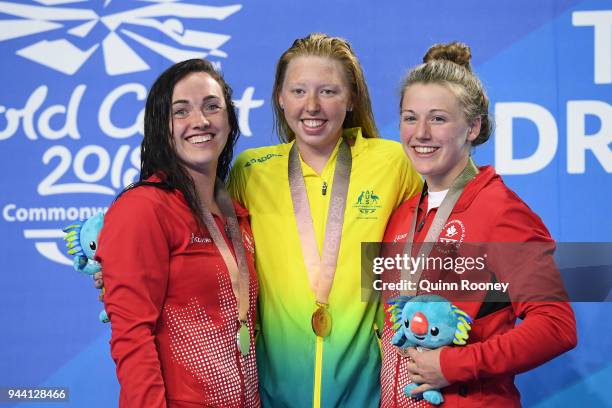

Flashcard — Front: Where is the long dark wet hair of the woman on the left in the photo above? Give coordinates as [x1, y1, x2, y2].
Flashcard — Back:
[120, 59, 239, 225]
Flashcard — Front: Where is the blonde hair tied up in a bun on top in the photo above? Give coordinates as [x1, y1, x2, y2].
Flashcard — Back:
[400, 42, 493, 146]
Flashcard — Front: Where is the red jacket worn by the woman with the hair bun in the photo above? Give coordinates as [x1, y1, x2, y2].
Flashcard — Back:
[381, 166, 577, 408]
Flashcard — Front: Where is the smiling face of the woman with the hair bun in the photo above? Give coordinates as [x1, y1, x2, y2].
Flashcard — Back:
[400, 83, 480, 191]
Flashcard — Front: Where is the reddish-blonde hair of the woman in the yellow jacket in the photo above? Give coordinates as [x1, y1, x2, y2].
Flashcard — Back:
[272, 33, 378, 142]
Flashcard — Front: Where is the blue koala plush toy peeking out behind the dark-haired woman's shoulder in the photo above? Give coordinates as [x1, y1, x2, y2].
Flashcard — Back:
[63, 213, 109, 323]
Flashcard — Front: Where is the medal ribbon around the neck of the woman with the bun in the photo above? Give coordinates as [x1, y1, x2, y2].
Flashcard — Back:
[400, 157, 478, 296]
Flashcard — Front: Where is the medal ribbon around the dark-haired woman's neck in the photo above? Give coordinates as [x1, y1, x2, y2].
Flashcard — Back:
[202, 183, 249, 336]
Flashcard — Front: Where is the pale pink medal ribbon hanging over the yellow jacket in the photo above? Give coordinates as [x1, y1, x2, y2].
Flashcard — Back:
[288, 140, 352, 305]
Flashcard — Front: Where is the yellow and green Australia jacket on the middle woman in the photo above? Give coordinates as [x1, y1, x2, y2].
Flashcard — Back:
[229, 128, 422, 408]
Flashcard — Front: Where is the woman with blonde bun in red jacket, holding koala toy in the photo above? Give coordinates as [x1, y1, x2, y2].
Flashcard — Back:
[381, 43, 577, 407]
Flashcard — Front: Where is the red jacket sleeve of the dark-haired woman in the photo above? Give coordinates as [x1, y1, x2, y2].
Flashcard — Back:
[96, 191, 169, 407]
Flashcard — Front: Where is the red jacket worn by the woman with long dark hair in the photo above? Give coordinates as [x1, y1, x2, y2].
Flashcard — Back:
[97, 182, 259, 408]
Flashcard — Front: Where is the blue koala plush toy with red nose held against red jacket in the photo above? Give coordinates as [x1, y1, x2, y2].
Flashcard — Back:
[388, 295, 472, 405]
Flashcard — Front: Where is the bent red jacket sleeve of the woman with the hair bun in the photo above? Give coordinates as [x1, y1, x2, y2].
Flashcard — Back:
[440, 197, 577, 384]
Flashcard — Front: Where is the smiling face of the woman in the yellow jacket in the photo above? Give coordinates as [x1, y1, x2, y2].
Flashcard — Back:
[278, 56, 351, 151]
